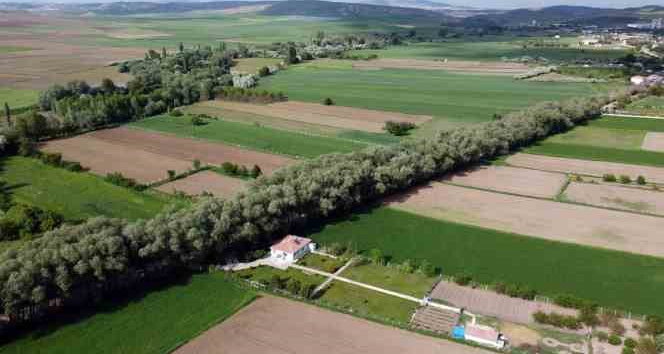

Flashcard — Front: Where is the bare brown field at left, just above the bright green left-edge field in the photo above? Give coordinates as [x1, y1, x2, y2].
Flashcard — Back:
[42, 134, 191, 183]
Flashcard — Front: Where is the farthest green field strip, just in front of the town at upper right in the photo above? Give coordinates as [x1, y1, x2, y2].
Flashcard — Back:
[356, 38, 627, 61]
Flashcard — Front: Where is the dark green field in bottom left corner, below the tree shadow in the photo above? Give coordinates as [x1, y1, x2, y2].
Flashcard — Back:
[0, 273, 256, 354]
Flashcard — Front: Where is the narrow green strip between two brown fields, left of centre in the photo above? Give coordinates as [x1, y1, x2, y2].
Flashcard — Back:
[130, 115, 367, 158]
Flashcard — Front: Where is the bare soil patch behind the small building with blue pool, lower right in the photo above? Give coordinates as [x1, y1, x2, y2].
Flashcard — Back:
[431, 281, 576, 324]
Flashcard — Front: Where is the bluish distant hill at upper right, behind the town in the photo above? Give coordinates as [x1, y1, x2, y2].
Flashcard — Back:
[470, 6, 664, 26]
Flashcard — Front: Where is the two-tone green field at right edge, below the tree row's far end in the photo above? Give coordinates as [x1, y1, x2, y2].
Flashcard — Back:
[524, 117, 664, 167]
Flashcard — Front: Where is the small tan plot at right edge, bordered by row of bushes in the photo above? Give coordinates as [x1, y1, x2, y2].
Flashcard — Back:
[564, 182, 664, 215]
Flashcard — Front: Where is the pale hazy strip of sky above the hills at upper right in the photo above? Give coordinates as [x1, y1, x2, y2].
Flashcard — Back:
[446, 0, 664, 8]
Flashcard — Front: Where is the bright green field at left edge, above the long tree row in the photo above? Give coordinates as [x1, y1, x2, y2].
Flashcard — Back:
[0, 157, 170, 220]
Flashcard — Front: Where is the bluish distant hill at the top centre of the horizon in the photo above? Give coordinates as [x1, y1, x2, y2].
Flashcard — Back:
[262, 0, 452, 23]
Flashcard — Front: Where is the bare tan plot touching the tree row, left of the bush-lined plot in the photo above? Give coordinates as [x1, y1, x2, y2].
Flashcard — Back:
[443, 166, 567, 198]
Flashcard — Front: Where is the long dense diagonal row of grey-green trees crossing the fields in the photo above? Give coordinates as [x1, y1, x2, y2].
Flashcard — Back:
[0, 79, 652, 324]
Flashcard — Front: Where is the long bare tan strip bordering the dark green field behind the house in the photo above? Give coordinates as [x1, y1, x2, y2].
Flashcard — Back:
[387, 183, 664, 257]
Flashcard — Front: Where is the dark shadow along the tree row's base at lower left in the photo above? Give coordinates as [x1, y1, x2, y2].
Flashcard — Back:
[0, 273, 192, 344]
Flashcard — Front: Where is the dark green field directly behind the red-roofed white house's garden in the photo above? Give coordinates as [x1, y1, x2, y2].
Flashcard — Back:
[311, 208, 664, 315]
